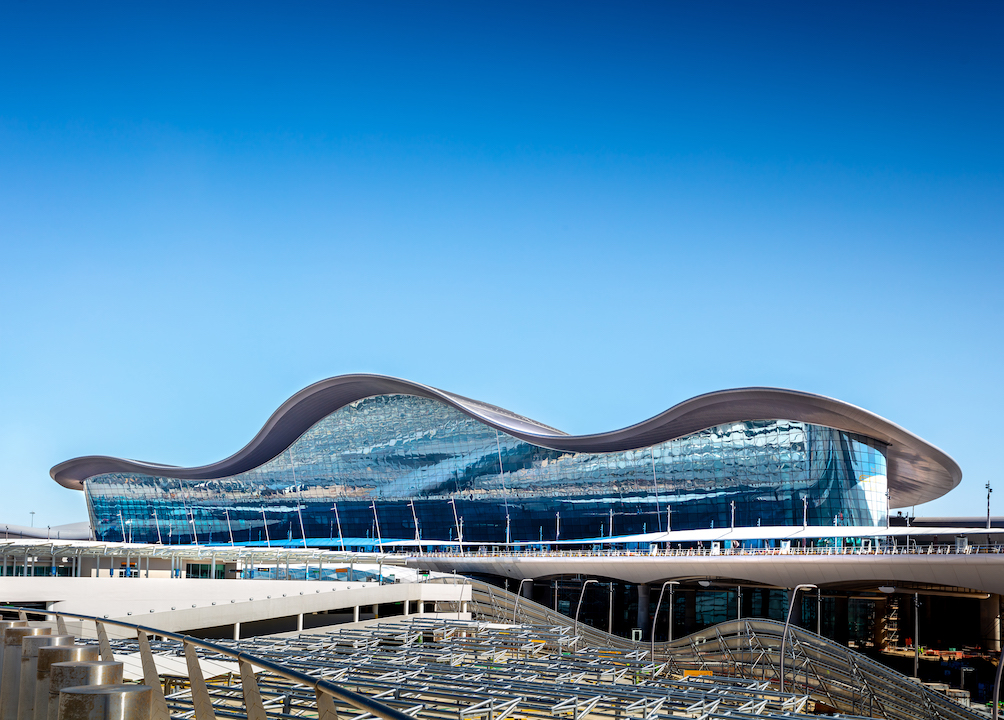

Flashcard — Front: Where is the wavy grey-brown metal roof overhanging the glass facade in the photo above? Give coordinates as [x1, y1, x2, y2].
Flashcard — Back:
[49, 375, 962, 507]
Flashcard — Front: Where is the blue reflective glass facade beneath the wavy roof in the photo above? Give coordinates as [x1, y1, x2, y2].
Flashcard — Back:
[85, 395, 887, 547]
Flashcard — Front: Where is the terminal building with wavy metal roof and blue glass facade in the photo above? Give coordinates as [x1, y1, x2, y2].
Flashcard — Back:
[51, 375, 962, 548]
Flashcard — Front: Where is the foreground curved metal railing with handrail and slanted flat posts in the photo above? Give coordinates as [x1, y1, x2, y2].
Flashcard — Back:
[0, 606, 411, 720]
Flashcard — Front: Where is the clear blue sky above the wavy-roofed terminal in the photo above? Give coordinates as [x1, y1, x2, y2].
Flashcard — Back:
[0, 1, 1004, 525]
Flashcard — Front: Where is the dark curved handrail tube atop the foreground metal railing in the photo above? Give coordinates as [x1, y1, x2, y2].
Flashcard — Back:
[0, 605, 414, 720]
